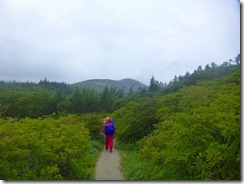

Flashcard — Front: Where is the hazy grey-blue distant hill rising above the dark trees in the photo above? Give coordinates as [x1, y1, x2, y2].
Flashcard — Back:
[71, 79, 147, 93]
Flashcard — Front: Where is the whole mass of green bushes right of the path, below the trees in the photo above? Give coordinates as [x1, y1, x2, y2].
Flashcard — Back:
[113, 67, 240, 180]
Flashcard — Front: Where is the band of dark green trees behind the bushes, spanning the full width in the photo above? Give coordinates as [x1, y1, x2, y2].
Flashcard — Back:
[0, 54, 240, 118]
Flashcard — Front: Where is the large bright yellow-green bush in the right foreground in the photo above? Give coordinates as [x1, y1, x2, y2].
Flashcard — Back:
[138, 70, 240, 180]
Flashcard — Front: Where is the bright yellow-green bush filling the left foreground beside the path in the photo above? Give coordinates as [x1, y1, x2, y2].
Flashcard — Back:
[0, 116, 98, 180]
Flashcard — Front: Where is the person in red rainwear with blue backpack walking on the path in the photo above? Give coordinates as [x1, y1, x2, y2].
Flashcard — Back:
[103, 118, 115, 153]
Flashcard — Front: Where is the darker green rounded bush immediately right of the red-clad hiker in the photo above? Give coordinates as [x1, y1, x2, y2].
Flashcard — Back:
[112, 97, 159, 142]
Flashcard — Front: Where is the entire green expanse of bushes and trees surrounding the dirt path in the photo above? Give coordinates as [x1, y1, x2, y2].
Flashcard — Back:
[0, 55, 241, 180]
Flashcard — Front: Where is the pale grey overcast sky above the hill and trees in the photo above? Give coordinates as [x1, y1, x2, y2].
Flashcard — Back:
[0, 0, 240, 85]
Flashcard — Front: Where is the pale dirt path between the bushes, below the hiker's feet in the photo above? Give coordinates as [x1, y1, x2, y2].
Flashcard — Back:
[95, 149, 124, 180]
